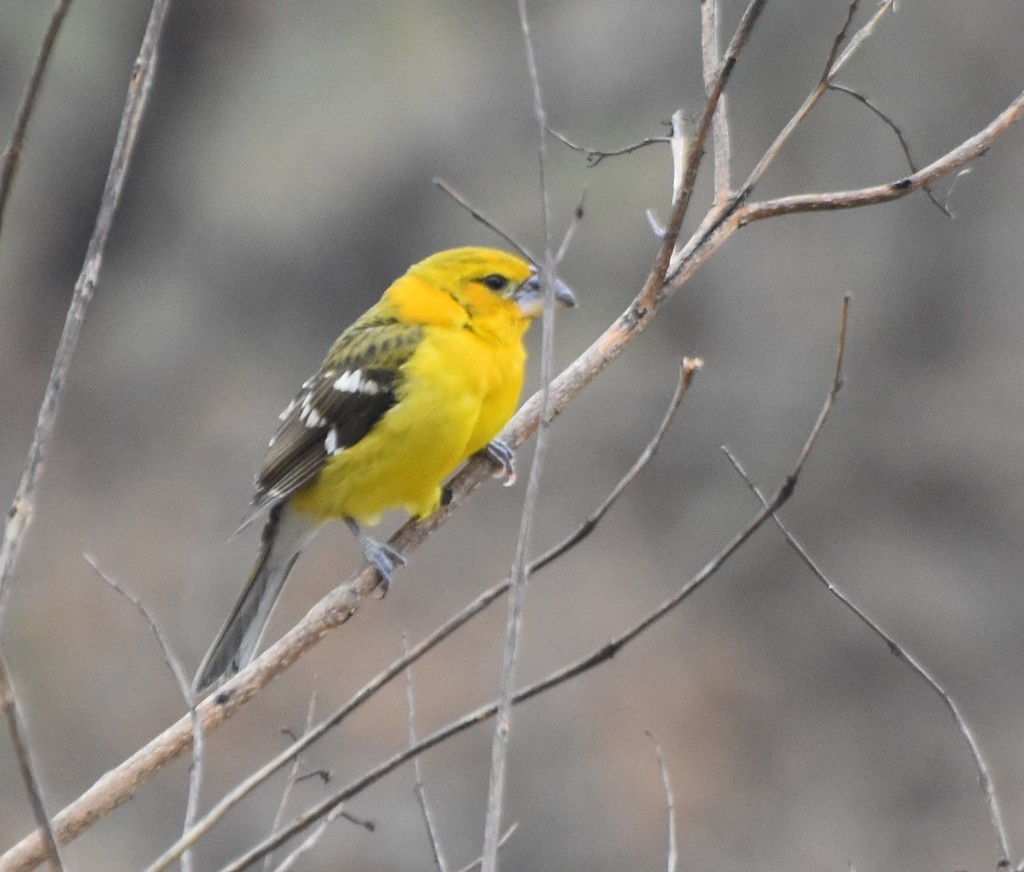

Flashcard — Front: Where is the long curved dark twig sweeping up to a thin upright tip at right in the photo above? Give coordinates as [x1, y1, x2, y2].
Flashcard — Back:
[214, 303, 848, 872]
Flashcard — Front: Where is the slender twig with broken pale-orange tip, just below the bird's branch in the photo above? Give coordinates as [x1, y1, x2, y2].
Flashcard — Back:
[146, 358, 701, 872]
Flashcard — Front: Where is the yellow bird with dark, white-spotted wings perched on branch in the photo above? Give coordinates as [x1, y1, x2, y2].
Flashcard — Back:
[193, 248, 575, 693]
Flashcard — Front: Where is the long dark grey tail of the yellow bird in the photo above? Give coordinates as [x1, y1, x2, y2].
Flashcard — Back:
[193, 503, 316, 695]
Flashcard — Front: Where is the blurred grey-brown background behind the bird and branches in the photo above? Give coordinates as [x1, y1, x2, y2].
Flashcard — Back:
[0, 0, 1024, 871]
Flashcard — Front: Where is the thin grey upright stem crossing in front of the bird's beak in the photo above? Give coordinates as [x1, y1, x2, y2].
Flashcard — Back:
[481, 0, 555, 872]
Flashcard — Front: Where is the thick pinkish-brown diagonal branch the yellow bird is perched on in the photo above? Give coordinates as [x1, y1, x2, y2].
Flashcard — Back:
[8, 13, 1024, 872]
